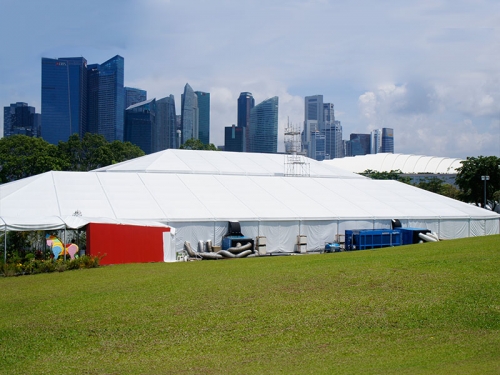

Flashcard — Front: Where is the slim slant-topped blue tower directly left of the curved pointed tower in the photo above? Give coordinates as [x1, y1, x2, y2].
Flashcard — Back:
[158, 95, 177, 152]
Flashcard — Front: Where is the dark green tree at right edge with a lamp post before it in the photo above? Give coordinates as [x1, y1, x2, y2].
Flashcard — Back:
[455, 156, 500, 207]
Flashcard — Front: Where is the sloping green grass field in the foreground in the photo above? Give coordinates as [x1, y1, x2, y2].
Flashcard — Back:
[0, 235, 500, 374]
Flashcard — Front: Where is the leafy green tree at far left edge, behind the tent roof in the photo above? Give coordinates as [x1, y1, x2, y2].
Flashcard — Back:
[0, 135, 67, 183]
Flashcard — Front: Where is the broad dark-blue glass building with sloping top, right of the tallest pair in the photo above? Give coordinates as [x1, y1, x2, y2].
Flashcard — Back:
[125, 99, 156, 154]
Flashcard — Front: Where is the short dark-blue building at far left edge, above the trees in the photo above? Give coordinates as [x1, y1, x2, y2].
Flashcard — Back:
[3, 102, 41, 137]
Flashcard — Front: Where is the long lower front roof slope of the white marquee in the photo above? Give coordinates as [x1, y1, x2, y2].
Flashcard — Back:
[0, 172, 499, 230]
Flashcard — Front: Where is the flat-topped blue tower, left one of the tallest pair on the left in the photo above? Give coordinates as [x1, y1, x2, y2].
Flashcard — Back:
[41, 57, 87, 144]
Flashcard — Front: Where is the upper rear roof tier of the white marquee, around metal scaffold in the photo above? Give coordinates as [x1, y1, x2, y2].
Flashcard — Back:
[95, 149, 365, 179]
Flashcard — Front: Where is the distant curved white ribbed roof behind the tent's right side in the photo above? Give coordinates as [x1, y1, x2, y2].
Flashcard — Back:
[323, 154, 463, 174]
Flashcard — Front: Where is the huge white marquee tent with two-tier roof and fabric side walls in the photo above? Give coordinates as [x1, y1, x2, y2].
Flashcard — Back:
[0, 150, 500, 252]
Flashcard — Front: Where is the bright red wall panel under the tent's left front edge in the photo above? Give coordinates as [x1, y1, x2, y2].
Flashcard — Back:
[87, 223, 170, 265]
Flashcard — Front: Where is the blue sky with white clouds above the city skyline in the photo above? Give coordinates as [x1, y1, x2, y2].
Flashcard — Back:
[0, 0, 500, 158]
